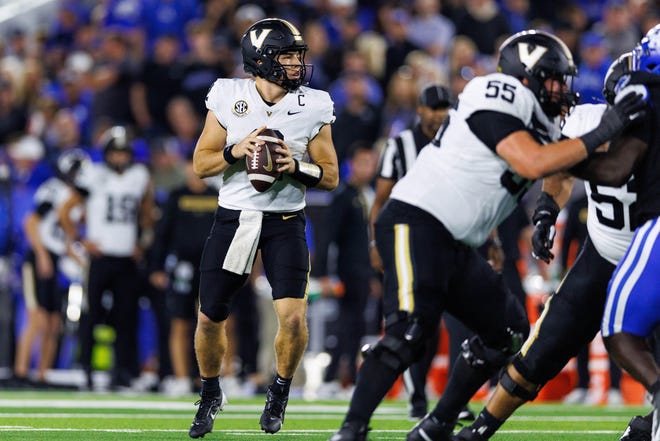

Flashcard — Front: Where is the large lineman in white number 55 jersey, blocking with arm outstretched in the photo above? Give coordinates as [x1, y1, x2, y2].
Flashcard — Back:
[331, 31, 643, 441]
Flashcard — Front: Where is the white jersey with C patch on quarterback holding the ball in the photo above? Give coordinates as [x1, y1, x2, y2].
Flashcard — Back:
[206, 78, 335, 211]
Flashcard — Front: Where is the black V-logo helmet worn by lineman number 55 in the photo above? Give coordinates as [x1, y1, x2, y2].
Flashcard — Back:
[497, 30, 577, 117]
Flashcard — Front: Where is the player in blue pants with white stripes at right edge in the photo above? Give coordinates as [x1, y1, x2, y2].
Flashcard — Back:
[601, 25, 660, 441]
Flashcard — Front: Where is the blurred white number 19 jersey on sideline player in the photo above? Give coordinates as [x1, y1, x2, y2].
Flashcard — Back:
[76, 163, 149, 257]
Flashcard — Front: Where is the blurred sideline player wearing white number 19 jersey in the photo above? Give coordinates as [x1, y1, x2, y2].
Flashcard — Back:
[59, 126, 154, 388]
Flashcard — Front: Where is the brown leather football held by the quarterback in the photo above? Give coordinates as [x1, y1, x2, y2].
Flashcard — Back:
[245, 129, 284, 192]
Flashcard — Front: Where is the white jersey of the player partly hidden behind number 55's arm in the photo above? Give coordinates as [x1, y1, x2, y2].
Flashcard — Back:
[562, 104, 637, 265]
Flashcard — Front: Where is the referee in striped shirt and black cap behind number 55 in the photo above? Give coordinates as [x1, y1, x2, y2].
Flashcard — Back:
[369, 84, 452, 419]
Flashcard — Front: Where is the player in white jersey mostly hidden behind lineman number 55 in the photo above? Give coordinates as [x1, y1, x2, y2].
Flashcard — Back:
[456, 53, 650, 441]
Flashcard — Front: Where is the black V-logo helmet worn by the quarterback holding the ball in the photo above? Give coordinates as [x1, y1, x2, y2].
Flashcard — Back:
[241, 18, 311, 91]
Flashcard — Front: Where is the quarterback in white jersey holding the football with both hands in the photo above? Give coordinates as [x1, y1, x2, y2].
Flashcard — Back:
[189, 18, 339, 438]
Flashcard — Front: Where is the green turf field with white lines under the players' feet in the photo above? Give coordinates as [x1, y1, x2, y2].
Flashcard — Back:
[0, 391, 647, 441]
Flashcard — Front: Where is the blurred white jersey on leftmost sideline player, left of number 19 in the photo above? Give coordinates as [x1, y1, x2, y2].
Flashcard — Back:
[34, 178, 74, 256]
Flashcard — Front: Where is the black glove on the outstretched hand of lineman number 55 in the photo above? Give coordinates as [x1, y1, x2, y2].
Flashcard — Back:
[580, 92, 646, 154]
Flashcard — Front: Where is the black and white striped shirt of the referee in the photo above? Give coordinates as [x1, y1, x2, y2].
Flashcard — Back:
[378, 124, 431, 181]
